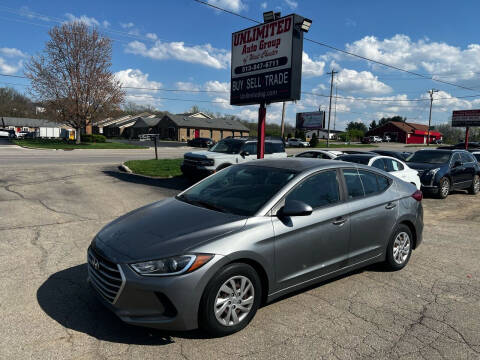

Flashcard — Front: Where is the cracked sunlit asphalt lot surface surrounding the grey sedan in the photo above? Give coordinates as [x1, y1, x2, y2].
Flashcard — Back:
[0, 148, 480, 360]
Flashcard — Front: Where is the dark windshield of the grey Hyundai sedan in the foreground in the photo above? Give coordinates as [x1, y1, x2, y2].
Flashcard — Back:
[177, 165, 297, 216]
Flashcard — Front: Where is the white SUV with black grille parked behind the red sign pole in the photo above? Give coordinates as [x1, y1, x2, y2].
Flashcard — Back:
[181, 137, 287, 178]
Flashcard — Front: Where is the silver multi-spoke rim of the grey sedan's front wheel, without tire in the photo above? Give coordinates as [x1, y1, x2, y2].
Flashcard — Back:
[213, 276, 255, 326]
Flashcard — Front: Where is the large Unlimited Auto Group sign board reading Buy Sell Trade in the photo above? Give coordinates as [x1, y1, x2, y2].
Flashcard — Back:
[230, 14, 303, 105]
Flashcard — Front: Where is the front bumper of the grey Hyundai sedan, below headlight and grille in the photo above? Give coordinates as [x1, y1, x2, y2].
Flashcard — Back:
[87, 249, 224, 330]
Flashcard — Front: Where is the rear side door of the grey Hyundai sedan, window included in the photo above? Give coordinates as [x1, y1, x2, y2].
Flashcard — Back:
[343, 169, 398, 265]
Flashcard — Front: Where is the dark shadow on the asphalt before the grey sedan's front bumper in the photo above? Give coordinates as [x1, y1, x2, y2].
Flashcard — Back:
[37, 264, 207, 346]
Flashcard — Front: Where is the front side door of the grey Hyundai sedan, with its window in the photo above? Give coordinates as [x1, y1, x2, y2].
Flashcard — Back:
[272, 170, 350, 289]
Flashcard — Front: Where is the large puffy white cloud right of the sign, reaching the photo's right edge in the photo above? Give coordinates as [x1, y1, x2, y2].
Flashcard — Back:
[346, 34, 480, 81]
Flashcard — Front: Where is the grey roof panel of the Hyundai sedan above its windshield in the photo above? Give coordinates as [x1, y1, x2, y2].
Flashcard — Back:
[241, 157, 351, 172]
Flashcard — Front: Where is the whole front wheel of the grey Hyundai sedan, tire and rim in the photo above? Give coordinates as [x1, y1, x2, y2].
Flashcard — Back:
[199, 263, 262, 336]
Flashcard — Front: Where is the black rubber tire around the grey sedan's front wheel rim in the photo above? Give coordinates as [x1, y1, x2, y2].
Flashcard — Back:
[199, 263, 262, 337]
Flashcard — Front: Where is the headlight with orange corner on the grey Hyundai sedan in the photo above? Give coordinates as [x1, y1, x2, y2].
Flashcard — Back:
[130, 254, 213, 276]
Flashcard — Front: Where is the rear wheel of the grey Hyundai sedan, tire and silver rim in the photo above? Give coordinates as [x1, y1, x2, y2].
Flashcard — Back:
[385, 224, 413, 270]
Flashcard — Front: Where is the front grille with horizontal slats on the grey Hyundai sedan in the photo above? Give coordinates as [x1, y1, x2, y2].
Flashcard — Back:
[87, 247, 124, 304]
